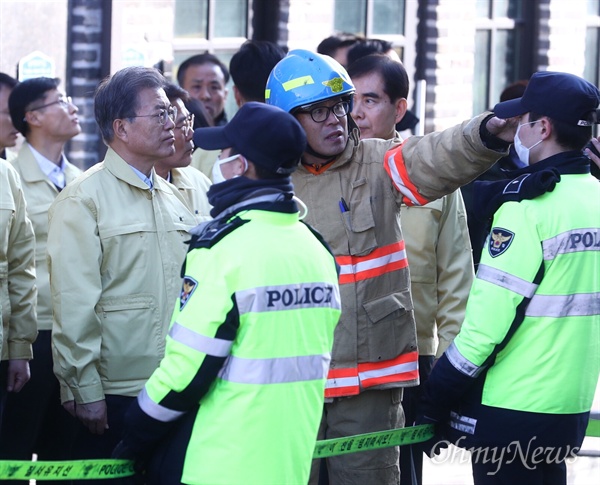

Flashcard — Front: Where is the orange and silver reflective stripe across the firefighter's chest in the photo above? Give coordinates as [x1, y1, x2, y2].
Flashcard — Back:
[335, 241, 408, 284]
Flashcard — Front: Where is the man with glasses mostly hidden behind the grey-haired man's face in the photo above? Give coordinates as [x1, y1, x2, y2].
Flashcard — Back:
[154, 83, 211, 223]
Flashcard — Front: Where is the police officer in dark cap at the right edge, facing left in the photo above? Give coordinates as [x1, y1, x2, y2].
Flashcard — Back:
[419, 72, 600, 485]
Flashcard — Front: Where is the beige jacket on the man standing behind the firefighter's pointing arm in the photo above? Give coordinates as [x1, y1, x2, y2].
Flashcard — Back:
[401, 190, 475, 357]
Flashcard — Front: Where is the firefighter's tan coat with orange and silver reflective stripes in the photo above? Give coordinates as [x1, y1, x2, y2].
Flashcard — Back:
[292, 115, 504, 398]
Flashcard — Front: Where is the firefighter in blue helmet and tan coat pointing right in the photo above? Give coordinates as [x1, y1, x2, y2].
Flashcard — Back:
[266, 49, 514, 485]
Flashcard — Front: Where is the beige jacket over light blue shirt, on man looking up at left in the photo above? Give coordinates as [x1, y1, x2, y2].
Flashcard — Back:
[10, 143, 81, 330]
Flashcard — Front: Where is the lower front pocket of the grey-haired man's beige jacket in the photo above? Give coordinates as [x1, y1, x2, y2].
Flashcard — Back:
[96, 295, 166, 382]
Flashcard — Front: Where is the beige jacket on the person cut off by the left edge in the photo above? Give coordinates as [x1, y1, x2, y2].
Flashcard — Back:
[0, 158, 37, 360]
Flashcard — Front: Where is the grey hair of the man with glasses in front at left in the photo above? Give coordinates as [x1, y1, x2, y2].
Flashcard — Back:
[94, 66, 167, 144]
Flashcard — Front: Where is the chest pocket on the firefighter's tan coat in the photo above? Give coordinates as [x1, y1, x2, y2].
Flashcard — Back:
[341, 178, 377, 256]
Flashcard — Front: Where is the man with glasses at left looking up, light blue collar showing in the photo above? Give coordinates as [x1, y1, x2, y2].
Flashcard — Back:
[0, 77, 81, 466]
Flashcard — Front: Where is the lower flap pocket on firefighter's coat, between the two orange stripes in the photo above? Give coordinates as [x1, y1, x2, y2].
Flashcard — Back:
[363, 290, 417, 362]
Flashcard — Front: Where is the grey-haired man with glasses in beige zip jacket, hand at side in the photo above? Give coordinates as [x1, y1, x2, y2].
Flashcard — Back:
[48, 67, 196, 466]
